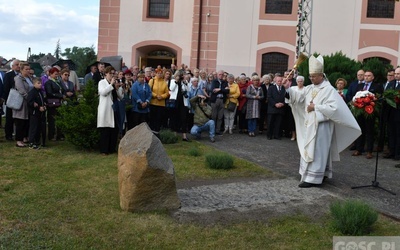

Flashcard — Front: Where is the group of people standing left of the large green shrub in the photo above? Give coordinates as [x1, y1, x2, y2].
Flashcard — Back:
[0, 59, 79, 149]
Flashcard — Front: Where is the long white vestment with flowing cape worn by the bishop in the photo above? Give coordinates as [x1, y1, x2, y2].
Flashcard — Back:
[288, 81, 361, 184]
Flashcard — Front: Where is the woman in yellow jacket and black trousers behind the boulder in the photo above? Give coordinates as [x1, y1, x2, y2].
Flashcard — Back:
[149, 69, 169, 136]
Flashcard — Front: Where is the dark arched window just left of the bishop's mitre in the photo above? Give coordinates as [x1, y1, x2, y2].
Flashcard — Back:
[261, 52, 289, 75]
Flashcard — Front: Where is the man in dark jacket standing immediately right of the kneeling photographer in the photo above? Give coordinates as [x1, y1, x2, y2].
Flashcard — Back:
[210, 70, 229, 135]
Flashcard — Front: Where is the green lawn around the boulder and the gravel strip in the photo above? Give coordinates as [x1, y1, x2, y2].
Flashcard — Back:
[0, 130, 400, 249]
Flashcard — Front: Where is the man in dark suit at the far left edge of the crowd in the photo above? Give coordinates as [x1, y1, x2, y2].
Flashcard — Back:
[3, 59, 19, 141]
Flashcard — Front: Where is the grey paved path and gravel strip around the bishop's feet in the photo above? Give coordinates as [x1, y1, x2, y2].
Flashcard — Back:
[175, 131, 400, 221]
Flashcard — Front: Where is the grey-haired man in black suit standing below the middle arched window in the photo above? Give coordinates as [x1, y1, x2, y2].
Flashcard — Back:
[267, 76, 286, 140]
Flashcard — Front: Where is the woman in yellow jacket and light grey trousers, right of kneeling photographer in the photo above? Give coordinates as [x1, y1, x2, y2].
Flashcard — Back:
[224, 74, 240, 134]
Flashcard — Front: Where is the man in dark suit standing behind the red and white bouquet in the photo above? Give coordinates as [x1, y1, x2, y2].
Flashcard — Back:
[353, 70, 383, 159]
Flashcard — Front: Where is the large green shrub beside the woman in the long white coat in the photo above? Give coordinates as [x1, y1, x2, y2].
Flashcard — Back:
[56, 80, 99, 149]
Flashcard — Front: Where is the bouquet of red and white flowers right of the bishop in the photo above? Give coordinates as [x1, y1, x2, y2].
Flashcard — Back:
[350, 91, 379, 118]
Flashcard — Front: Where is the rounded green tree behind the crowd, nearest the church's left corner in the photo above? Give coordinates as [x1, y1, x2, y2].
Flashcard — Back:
[61, 45, 97, 77]
